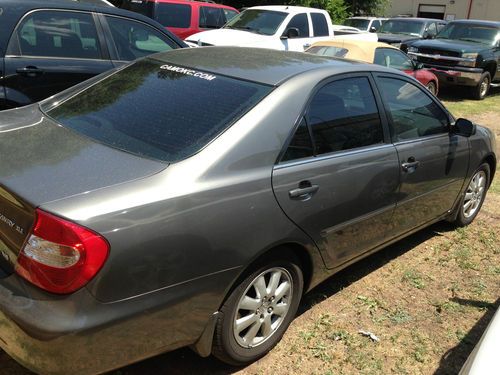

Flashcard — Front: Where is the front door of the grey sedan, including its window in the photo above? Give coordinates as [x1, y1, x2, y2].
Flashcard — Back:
[376, 74, 469, 235]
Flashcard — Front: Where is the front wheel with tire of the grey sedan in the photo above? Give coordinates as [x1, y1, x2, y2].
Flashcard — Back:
[455, 163, 490, 227]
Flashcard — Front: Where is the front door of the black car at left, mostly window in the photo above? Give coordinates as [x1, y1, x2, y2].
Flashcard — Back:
[99, 14, 179, 66]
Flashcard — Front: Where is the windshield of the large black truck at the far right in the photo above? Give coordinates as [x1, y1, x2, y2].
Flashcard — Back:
[437, 23, 500, 45]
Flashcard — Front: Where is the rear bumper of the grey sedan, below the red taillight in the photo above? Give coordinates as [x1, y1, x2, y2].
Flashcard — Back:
[0, 270, 236, 375]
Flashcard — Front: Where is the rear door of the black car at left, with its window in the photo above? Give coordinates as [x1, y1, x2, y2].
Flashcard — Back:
[4, 10, 113, 106]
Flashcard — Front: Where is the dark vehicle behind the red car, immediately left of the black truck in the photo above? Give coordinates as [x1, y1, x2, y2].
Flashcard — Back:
[377, 17, 446, 52]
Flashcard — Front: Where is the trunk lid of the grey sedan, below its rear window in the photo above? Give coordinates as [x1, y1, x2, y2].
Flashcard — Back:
[0, 104, 168, 277]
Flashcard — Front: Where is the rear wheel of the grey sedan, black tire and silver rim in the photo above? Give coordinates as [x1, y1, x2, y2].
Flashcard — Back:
[212, 259, 303, 366]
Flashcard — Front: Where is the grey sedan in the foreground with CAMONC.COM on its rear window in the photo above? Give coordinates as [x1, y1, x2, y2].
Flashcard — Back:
[0, 47, 496, 375]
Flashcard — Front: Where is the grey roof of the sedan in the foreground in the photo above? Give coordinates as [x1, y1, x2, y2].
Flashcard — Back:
[150, 47, 402, 86]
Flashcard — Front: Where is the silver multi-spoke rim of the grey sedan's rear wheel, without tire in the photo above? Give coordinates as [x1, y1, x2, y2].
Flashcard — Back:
[233, 267, 292, 348]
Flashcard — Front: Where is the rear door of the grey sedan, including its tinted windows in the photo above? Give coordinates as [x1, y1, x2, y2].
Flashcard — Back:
[272, 75, 399, 267]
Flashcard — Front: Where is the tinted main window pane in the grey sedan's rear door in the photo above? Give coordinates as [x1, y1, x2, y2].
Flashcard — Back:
[306, 77, 383, 154]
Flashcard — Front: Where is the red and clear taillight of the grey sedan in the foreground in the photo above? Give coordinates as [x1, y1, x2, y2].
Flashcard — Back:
[16, 209, 109, 294]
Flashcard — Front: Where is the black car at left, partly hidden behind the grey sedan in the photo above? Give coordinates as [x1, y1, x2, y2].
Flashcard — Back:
[0, 0, 186, 110]
